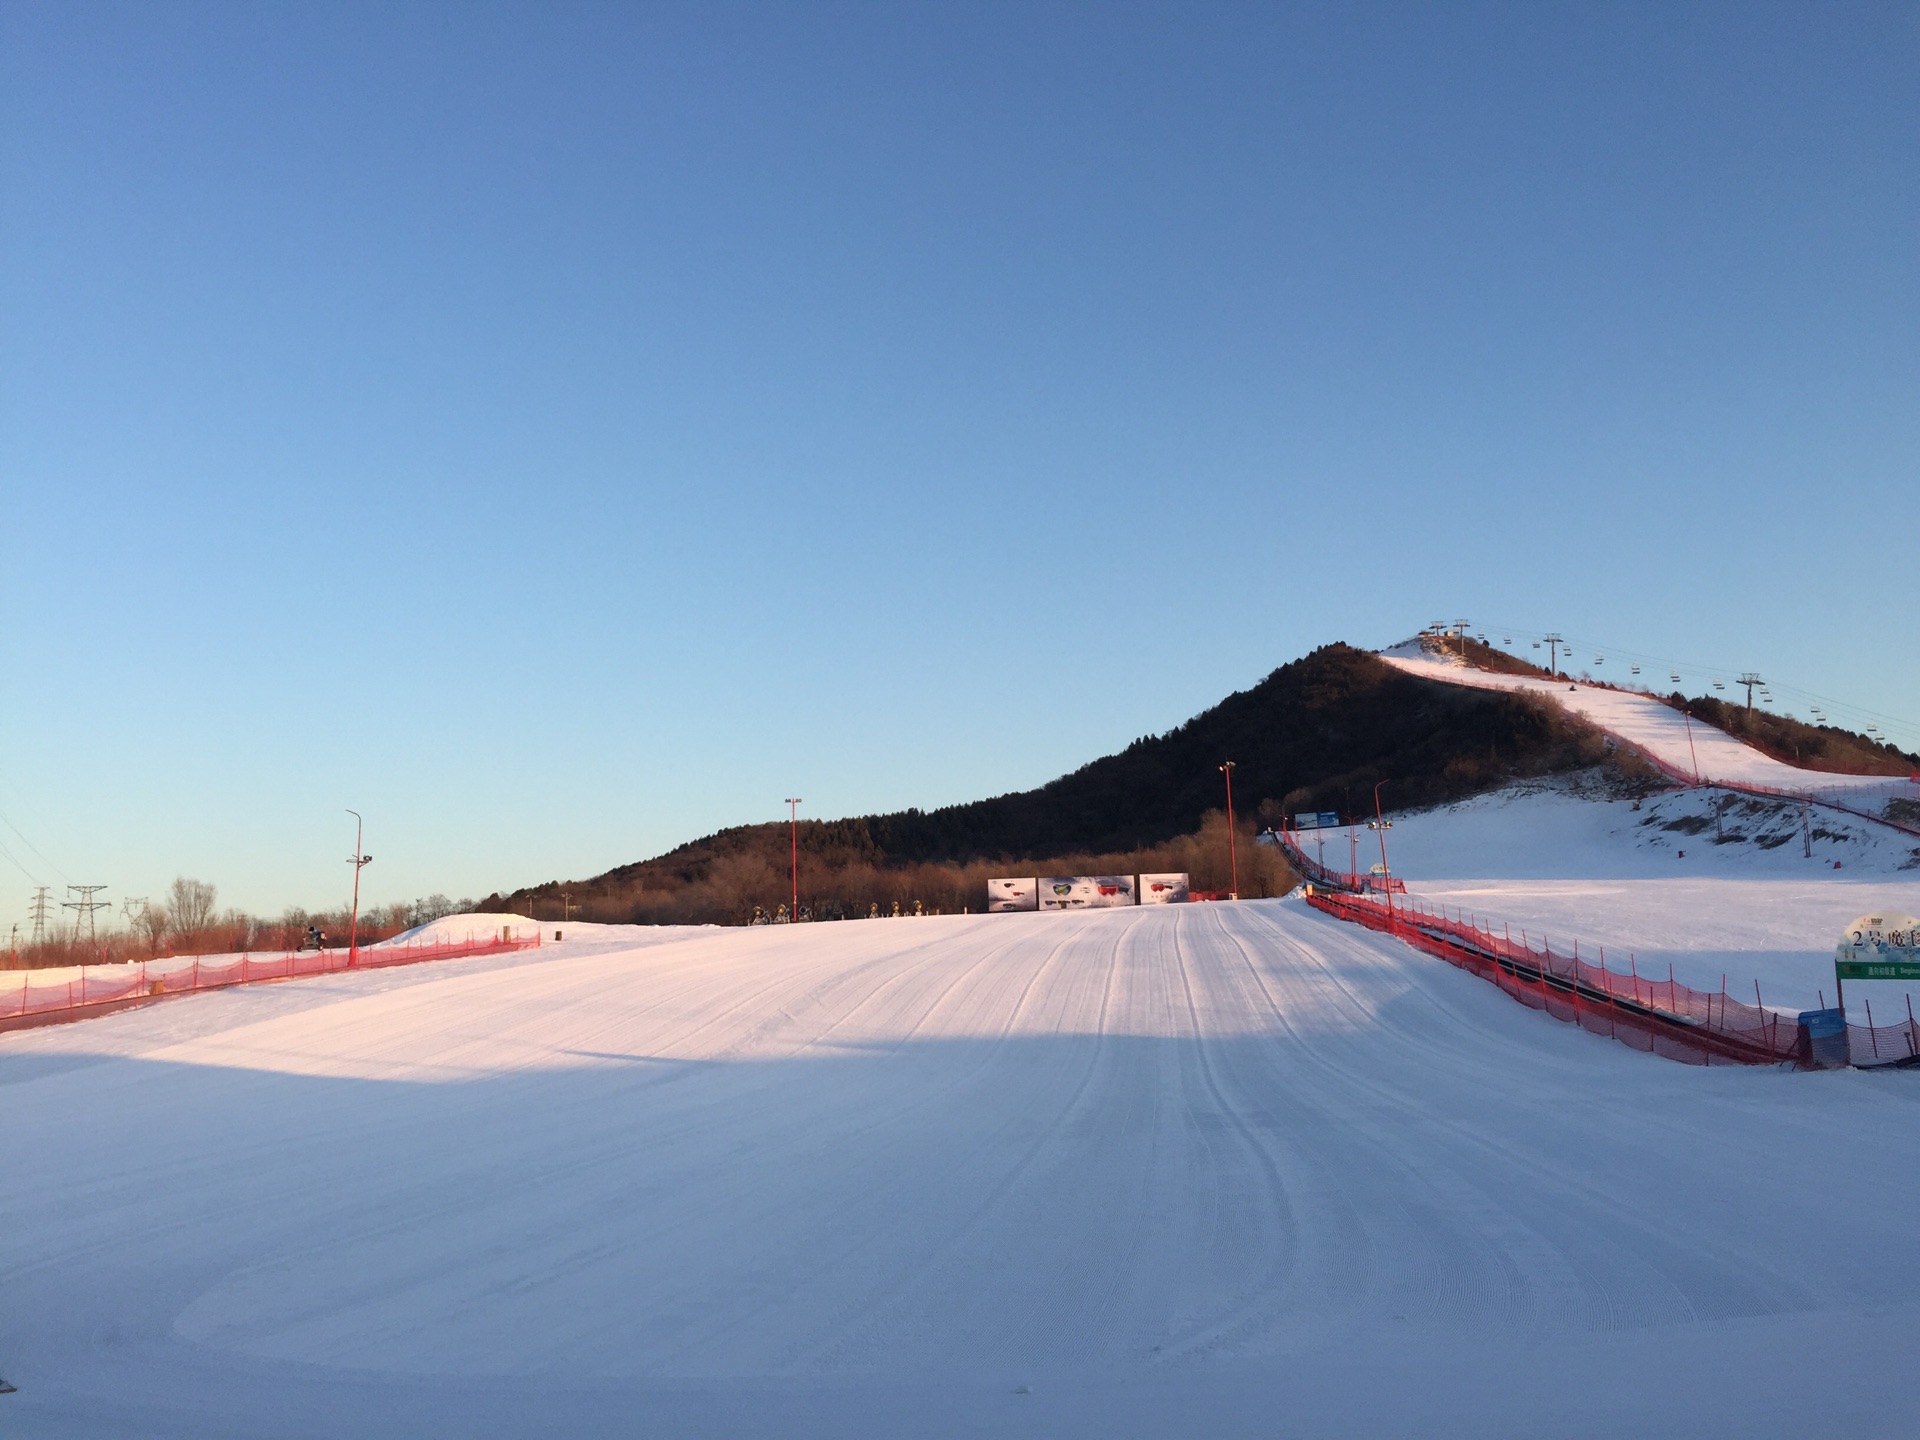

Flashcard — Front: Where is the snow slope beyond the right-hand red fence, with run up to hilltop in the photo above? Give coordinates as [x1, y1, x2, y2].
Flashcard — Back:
[1367, 641, 1920, 1023]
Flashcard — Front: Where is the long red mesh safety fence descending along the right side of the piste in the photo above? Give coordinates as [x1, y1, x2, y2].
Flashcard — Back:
[1308, 887, 1920, 1069]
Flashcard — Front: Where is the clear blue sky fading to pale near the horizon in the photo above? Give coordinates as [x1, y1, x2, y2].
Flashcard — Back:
[0, 0, 1920, 917]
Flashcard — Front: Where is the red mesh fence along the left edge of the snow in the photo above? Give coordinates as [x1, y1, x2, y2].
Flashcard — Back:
[0, 933, 540, 1029]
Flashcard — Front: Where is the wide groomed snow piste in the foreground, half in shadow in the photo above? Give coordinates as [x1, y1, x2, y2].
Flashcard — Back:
[0, 906, 1920, 1440]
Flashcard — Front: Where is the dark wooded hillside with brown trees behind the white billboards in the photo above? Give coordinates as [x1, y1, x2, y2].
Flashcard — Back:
[486, 645, 1635, 924]
